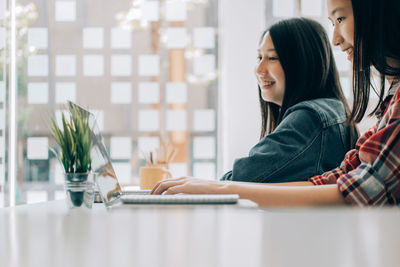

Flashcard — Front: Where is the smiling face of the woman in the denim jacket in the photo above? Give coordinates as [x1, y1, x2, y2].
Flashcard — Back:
[255, 33, 285, 106]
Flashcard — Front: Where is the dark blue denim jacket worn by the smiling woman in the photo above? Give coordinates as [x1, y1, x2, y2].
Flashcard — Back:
[221, 98, 351, 183]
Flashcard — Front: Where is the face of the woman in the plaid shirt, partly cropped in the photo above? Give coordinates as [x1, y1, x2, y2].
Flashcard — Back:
[328, 0, 354, 61]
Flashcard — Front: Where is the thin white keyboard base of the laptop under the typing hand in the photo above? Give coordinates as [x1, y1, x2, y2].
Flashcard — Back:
[121, 194, 239, 204]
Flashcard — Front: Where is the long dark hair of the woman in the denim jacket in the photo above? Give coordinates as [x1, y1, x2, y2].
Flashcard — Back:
[258, 18, 358, 146]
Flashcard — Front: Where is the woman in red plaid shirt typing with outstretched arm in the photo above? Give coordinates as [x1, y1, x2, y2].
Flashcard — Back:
[152, 0, 400, 206]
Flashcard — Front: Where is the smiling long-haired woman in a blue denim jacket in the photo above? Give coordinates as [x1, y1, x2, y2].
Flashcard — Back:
[221, 18, 358, 183]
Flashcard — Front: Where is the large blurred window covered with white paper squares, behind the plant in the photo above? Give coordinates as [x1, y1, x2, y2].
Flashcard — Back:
[0, 0, 218, 205]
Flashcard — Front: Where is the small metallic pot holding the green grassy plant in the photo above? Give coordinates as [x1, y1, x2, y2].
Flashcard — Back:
[64, 173, 94, 209]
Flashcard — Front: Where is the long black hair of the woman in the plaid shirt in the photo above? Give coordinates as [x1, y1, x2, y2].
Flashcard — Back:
[349, 0, 400, 122]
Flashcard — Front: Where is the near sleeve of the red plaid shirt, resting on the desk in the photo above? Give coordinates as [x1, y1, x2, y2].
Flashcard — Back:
[337, 120, 400, 206]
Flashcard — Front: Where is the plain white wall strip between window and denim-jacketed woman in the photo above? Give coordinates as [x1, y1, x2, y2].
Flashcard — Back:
[218, 0, 266, 177]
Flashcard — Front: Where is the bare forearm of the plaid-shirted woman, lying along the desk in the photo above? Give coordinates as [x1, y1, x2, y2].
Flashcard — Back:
[222, 183, 345, 207]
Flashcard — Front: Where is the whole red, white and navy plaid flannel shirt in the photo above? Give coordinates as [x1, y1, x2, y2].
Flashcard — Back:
[309, 80, 400, 206]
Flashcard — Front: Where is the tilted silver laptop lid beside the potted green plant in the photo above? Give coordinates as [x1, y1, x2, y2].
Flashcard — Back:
[68, 101, 122, 207]
